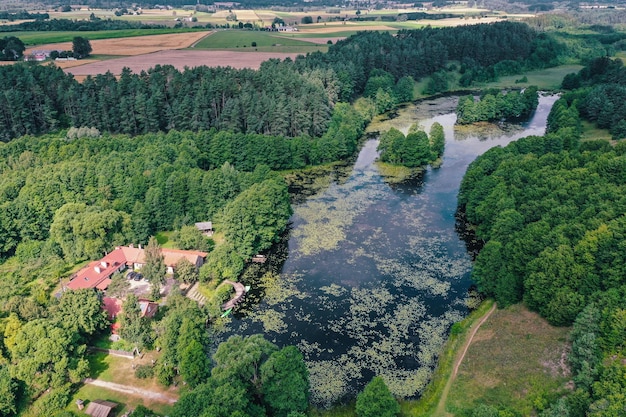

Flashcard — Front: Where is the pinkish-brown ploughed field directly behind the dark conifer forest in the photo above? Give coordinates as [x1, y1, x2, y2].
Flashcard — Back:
[66, 50, 298, 79]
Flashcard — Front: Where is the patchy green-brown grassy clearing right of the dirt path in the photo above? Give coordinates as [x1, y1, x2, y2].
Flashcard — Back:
[442, 304, 570, 415]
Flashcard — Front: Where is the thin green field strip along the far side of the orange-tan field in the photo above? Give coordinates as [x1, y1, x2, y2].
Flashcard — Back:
[11, 29, 206, 46]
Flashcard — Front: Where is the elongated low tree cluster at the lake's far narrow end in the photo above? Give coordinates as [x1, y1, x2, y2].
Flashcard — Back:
[456, 86, 539, 124]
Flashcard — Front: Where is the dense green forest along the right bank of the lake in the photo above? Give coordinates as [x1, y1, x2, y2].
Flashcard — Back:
[459, 58, 626, 417]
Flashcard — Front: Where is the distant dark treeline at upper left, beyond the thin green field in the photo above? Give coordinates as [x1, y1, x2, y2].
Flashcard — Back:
[0, 17, 167, 32]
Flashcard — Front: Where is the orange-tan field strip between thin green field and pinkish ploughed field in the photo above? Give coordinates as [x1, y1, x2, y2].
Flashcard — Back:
[25, 31, 211, 56]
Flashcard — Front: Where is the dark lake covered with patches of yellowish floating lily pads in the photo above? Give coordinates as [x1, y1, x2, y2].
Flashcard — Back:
[218, 92, 557, 406]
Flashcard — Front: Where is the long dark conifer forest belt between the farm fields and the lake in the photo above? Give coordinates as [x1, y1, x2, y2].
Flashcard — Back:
[0, 22, 565, 141]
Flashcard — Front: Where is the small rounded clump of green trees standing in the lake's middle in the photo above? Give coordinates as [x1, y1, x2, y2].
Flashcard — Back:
[378, 123, 446, 168]
